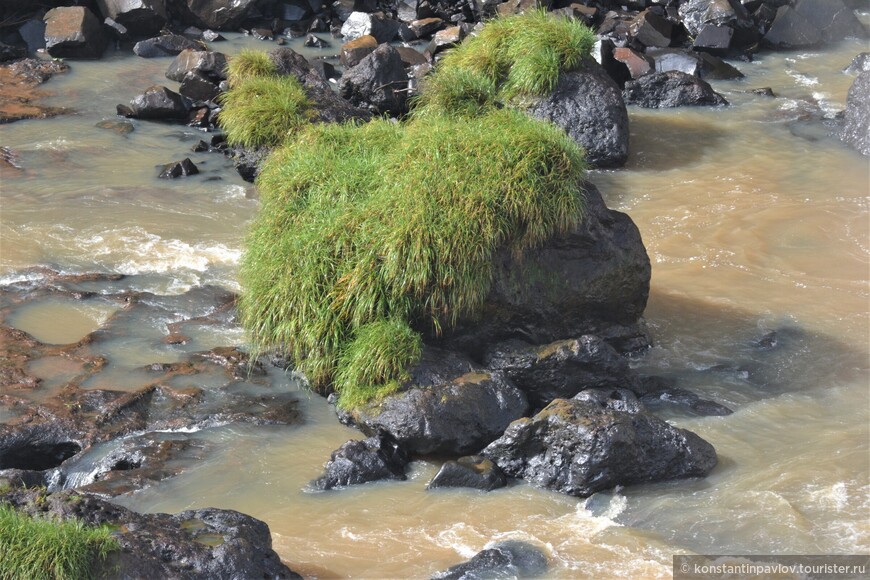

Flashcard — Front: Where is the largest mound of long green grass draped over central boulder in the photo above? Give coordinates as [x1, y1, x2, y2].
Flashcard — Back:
[239, 109, 585, 408]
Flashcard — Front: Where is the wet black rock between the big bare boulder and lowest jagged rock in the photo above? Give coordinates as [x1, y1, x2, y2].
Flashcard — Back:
[483, 334, 631, 409]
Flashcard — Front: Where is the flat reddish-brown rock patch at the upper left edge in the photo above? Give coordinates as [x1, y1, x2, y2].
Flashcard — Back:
[0, 58, 69, 124]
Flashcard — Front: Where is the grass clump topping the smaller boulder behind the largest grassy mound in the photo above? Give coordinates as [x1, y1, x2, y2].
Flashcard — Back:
[417, 10, 595, 115]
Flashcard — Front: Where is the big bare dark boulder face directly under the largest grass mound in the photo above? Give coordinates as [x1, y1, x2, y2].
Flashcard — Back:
[427, 183, 650, 360]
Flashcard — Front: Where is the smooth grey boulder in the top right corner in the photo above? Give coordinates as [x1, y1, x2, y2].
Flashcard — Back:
[764, 0, 867, 48]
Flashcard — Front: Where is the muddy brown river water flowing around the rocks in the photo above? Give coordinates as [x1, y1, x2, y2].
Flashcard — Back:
[0, 30, 870, 578]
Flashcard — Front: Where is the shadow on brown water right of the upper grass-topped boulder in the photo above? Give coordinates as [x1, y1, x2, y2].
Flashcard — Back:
[625, 109, 726, 171]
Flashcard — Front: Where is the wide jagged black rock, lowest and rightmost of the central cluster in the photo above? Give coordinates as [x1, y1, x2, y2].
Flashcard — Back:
[482, 393, 717, 497]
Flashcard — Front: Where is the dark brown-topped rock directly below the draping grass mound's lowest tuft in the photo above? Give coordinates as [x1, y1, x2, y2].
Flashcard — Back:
[339, 347, 528, 455]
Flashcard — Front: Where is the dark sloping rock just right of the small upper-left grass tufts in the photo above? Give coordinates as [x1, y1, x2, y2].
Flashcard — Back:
[270, 47, 371, 123]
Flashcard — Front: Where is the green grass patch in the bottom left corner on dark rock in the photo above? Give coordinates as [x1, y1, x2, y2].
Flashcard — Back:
[0, 505, 119, 580]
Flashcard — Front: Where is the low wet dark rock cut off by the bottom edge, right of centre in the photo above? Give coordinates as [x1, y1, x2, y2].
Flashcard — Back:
[432, 540, 547, 580]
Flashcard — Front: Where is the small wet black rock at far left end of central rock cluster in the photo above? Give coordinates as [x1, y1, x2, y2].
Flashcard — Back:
[311, 432, 411, 490]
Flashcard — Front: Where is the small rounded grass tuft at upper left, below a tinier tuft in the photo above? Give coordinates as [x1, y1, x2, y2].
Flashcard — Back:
[219, 75, 314, 147]
